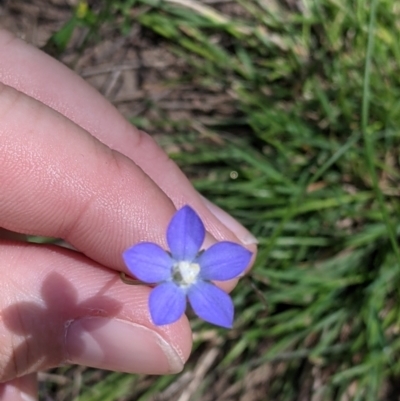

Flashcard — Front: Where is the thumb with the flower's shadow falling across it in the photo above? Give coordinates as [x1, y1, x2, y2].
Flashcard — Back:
[0, 242, 191, 381]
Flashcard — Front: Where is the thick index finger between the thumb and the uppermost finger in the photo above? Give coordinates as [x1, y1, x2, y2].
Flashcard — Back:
[0, 84, 255, 289]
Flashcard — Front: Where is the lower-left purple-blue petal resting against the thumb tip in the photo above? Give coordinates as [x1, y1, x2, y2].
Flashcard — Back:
[149, 282, 186, 326]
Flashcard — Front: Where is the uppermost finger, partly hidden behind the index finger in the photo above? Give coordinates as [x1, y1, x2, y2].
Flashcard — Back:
[0, 31, 257, 248]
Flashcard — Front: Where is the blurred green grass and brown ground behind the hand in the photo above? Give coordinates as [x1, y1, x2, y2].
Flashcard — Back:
[2, 0, 400, 401]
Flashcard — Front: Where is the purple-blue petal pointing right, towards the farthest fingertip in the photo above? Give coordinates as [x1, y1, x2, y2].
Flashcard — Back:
[197, 241, 252, 281]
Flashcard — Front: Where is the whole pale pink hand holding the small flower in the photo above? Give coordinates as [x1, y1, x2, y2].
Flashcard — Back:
[0, 30, 256, 401]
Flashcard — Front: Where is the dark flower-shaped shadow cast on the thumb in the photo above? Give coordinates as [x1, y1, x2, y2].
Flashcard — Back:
[0, 272, 122, 386]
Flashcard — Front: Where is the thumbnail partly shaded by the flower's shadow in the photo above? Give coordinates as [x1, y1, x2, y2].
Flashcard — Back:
[66, 317, 183, 374]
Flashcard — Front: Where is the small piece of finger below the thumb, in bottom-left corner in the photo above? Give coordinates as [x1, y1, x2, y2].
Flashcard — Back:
[0, 373, 38, 401]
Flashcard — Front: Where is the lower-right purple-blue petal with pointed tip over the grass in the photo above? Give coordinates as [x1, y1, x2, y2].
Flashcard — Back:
[188, 281, 233, 329]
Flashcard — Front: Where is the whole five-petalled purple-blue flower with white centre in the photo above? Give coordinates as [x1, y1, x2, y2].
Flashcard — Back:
[123, 206, 252, 328]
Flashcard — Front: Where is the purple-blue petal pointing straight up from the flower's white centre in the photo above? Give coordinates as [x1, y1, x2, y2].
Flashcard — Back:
[167, 206, 205, 262]
